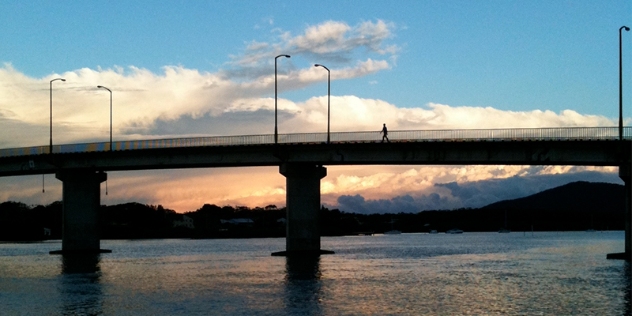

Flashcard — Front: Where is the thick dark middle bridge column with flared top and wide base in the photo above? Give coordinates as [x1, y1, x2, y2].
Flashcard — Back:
[272, 163, 333, 256]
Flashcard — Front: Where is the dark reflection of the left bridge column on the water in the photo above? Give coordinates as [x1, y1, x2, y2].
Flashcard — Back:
[59, 254, 103, 315]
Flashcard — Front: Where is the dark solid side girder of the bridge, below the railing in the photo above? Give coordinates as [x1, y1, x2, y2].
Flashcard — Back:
[0, 140, 632, 177]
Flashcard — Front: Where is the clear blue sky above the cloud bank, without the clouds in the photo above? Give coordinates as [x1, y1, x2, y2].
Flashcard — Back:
[0, 1, 632, 117]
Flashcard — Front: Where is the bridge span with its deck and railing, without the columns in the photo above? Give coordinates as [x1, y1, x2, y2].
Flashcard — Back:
[0, 128, 632, 177]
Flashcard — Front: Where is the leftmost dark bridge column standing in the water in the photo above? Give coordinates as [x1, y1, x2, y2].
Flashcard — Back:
[50, 170, 111, 254]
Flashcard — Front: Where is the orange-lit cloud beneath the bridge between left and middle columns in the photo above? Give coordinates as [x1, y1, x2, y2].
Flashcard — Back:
[102, 167, 285, 212]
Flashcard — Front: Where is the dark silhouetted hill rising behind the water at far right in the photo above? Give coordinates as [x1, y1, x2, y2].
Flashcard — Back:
[410, 182, 625, 232]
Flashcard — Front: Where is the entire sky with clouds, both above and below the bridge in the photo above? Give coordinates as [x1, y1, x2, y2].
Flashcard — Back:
[0, 0, 632, 213]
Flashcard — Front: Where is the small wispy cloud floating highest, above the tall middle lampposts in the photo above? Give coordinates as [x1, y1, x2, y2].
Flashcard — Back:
[221, 20, 399, 80]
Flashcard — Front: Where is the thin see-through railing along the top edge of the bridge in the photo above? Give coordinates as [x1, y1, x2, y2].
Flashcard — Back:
[0, 127, 632, 157]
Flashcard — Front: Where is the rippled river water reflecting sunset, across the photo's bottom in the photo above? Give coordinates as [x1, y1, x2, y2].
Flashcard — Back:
[0, 232, 630, 315]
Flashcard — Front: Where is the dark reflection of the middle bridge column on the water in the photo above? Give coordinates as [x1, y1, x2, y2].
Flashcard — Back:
[284, 255, 322, 315]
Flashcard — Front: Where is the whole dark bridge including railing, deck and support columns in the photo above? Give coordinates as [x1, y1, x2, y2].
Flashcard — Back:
[0, 127, 632, 259]
